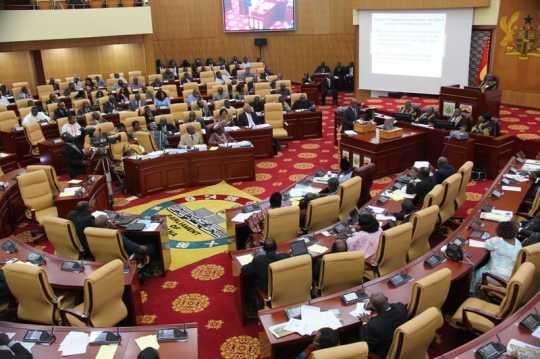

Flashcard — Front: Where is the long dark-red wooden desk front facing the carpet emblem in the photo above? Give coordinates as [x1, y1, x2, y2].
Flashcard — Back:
[124, 147, 255, 197]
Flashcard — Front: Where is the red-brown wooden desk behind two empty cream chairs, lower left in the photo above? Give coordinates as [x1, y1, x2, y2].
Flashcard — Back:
[0, 236, 142, 325]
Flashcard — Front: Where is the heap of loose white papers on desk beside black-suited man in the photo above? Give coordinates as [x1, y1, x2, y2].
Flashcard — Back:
[280, 305, 341, 335]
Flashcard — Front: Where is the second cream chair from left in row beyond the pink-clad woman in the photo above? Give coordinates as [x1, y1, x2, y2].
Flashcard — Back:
[306, 195, 339, 232]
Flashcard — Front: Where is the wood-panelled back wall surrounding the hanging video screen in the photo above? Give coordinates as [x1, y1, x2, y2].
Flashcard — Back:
[152, 0, 355, 80]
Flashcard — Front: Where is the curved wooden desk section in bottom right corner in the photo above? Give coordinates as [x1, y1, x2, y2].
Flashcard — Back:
[436, 293, 540, 359]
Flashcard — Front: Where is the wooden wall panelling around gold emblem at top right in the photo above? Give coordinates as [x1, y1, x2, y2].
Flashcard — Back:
[493, 0, 540, 108]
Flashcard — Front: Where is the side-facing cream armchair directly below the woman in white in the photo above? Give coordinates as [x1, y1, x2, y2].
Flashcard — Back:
[452, 262, 535, 334]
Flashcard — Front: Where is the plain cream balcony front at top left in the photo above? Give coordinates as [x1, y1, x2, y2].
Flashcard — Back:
[0, 6, 153, 42]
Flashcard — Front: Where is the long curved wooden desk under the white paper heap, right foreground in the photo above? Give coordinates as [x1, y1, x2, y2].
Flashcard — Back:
[258, 159, 531, 358]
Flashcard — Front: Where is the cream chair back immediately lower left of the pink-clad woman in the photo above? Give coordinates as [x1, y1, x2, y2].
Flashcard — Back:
[318, 251, 364, 295]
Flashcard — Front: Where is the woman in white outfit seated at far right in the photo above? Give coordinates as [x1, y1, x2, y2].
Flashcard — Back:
[471, 221, 522, 293]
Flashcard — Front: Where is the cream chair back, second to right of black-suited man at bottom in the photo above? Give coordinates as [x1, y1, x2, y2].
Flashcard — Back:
[407, 268, 452, 318]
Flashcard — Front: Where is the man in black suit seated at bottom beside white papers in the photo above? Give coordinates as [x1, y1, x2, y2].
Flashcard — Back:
[359, 293, 408, 358]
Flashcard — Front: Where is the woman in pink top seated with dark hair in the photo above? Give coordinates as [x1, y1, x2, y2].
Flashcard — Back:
[347, 213, 383, 259]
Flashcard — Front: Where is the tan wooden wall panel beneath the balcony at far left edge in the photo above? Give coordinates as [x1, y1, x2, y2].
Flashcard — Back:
[0, 51, 35, 88]
